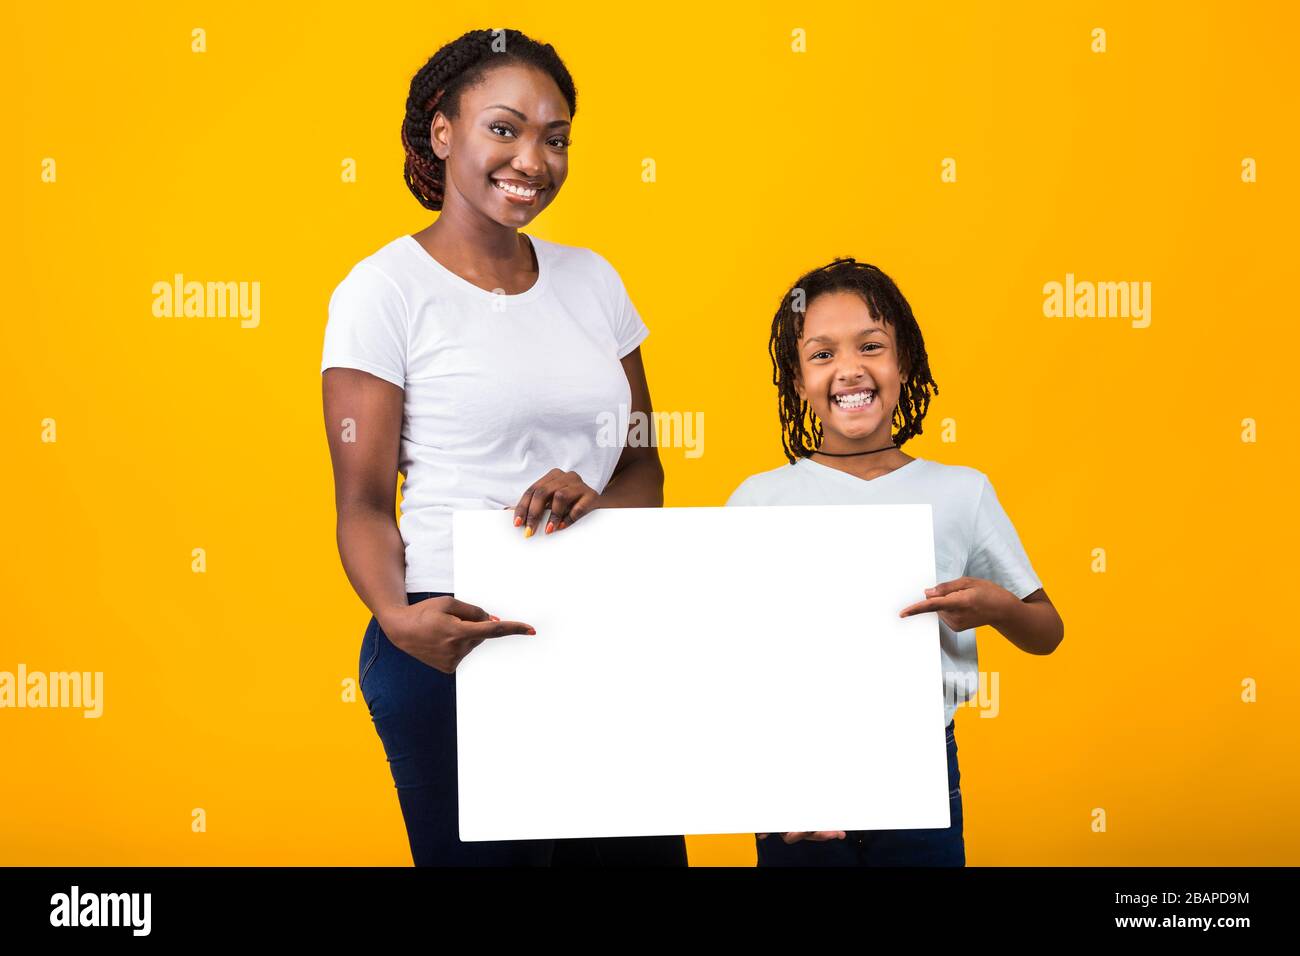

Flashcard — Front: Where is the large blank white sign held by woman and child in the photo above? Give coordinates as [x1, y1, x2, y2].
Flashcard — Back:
[452, 505, 952, 840]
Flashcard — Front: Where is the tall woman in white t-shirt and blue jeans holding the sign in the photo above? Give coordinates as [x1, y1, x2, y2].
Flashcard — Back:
[321, 30, 686, 866]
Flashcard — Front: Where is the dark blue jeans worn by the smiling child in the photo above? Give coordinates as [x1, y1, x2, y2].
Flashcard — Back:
[755, 721, 966, 866]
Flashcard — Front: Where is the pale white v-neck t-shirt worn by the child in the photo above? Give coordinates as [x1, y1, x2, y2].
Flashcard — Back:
[727, 458, 1043, 724]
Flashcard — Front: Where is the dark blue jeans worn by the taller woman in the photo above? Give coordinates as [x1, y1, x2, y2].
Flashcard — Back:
[358, 591, 686, 866]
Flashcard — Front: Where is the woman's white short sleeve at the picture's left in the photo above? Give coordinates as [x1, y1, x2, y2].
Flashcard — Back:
[321, 263, 407, 388]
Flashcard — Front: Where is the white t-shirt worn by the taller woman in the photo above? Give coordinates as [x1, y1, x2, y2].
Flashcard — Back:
[321, 235, 650, 590]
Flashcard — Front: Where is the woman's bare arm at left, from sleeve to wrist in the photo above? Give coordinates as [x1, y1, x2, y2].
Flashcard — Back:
[321, 368, 407, 627]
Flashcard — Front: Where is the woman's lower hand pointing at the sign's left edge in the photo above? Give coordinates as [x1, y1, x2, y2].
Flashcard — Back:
[380, 596, 537, 674]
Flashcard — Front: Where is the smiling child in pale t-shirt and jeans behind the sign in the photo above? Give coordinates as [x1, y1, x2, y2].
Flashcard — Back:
[727, 259, 1065, 866]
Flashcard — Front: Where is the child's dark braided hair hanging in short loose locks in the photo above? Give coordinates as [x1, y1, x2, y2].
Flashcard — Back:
[768, 258, 939, 464]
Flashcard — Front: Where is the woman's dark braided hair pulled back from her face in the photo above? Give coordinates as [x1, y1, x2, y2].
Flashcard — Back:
[402, 30, 577, 209]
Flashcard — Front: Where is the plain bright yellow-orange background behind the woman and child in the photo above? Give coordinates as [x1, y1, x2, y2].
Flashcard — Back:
[0, 3, 1300, 865]
